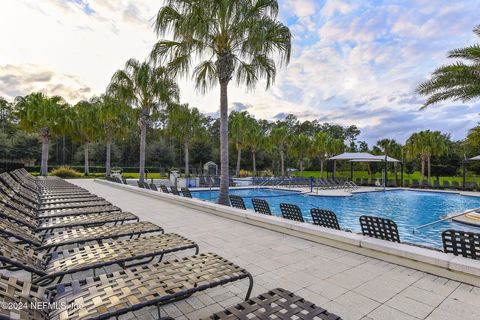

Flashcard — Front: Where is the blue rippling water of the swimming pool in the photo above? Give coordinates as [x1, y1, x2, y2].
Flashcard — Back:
[192, 189, 480, 248]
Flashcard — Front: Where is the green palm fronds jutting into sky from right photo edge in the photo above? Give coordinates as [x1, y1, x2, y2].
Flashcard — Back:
[416, 25, 480, 108]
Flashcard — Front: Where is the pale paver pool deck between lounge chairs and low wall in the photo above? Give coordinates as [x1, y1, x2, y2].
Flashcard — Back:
[61, 180, 480, 320]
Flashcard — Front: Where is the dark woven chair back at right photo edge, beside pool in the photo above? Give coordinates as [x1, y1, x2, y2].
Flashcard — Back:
[442, 229, 480, 260]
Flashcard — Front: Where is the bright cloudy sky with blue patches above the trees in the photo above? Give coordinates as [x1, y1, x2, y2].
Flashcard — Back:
[0, 0, 480, 146]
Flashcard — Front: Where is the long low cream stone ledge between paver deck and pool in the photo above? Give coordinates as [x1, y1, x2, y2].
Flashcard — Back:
[94, 179, 480, 286]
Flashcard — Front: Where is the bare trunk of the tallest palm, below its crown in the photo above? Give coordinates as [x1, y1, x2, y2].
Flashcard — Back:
[218, 81, 229, 206]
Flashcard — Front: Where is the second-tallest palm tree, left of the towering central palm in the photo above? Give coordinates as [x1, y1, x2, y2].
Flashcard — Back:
[108, 59, 179, 181]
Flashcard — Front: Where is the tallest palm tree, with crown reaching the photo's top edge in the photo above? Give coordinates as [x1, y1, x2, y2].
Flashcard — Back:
[152, 0, 291, 205]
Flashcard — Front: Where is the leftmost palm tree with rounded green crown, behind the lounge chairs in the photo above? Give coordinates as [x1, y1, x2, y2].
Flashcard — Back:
[15, 92, 67, 176]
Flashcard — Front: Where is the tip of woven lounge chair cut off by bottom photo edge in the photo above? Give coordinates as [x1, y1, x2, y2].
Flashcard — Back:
[204, 288, 341, 320]
